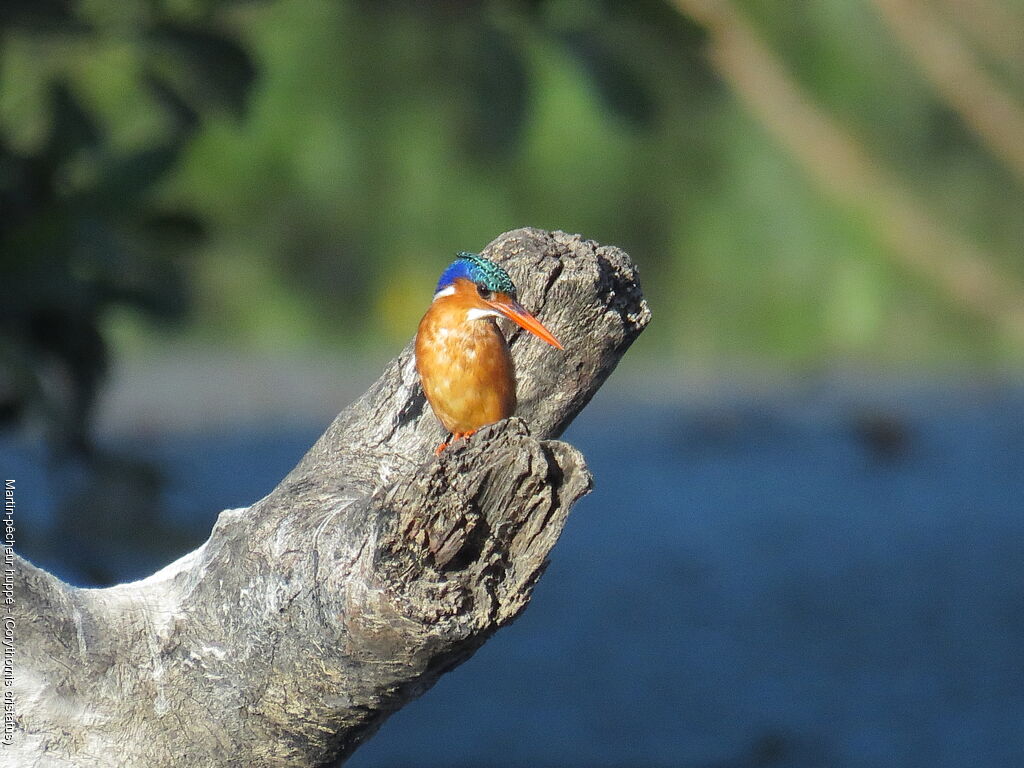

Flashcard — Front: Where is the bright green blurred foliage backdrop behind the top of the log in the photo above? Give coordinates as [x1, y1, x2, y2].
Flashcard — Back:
[180, 0, 1024, 366]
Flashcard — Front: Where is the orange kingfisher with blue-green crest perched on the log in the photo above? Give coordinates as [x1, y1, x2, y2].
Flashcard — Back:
[416, 251, 562, 454]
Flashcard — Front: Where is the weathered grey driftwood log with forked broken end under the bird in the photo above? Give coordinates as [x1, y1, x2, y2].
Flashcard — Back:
[6, 229, 649, 768]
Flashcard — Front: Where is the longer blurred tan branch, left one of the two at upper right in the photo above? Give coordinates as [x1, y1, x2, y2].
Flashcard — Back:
[672, 0, 1024, 343]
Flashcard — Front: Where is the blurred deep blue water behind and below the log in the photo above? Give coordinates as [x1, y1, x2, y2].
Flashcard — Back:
[8, 386, 1024, 768]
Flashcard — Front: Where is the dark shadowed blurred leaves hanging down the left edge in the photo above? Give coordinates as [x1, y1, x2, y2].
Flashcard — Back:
[0, 0, 256, 583]
